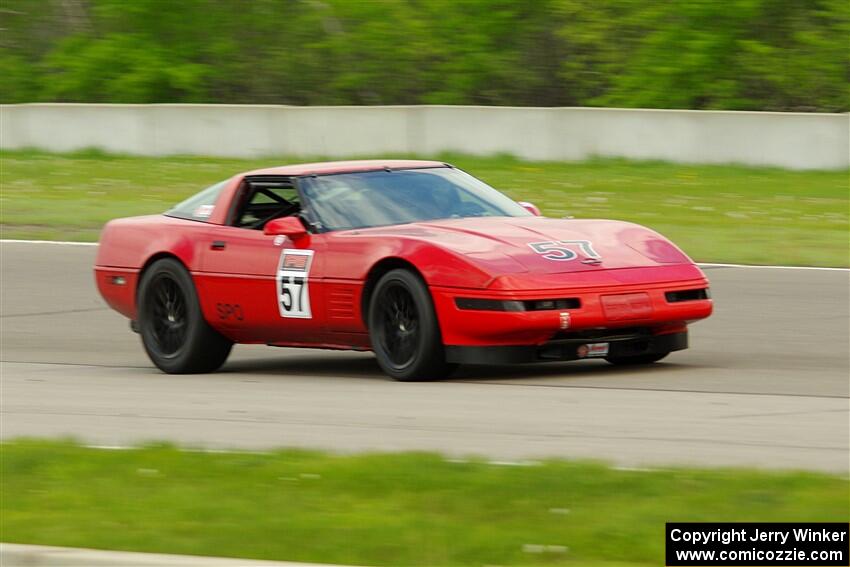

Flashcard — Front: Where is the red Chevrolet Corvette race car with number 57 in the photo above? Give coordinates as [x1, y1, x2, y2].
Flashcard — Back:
[95, 160, 712, 380]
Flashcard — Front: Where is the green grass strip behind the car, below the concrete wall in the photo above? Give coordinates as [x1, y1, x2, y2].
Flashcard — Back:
[0, 151, 850, 266]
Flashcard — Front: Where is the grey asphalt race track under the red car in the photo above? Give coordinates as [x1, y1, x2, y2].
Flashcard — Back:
[0, 242, 850, 476]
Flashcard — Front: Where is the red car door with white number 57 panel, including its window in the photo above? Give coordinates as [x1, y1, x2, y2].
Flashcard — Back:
[198, 180, 325, 346]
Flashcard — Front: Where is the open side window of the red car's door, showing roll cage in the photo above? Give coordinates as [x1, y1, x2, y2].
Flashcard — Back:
[233, 179, 301, 230]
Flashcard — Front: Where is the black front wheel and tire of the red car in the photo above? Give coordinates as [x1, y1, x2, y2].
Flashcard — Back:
[367, 269, 457, 382]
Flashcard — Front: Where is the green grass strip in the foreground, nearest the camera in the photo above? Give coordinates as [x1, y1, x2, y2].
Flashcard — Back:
[0, 440, 850, 566]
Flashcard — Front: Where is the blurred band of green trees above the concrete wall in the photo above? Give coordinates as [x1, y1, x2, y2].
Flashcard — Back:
[0, 0, 850, 112]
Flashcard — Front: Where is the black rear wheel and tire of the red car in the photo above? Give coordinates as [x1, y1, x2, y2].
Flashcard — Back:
[138, 258, 233, 374]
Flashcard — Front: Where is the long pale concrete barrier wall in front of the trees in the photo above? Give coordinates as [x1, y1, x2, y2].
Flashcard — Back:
[0, 104, 850, 169]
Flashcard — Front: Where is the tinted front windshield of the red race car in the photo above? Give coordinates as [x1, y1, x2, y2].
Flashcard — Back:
[301, 167, 531, 230]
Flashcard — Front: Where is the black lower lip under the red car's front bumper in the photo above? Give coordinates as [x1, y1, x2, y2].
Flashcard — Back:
[445, 331, 688, 364]
